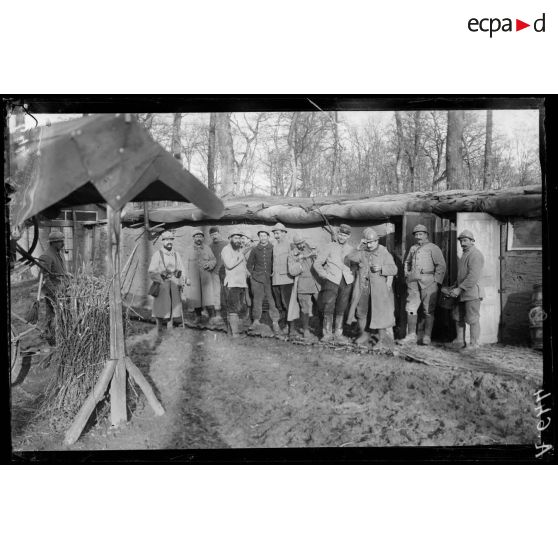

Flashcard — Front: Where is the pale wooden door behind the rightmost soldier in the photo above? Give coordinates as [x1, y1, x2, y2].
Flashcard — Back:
[456, 213, 501, 343]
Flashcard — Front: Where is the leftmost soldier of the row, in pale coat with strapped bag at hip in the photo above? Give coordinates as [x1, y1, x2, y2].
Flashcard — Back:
[148, 231, 189, 332]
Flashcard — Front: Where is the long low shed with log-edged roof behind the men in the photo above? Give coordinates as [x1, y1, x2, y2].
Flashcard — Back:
[94, 186, 543, 344]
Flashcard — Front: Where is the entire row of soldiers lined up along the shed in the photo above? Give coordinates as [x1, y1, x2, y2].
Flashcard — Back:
[149, 223, 484, 349]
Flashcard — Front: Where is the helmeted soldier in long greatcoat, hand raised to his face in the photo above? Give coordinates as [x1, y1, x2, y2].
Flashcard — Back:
[347, 228, 397, 346]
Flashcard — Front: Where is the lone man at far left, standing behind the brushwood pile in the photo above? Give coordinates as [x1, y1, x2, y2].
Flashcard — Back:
[39, 231, 69, 345]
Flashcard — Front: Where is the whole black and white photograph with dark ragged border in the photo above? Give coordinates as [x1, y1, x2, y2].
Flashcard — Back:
[5, 96, 549, 457]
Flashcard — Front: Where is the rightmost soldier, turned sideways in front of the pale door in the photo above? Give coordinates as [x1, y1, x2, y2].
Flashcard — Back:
[449, 230, 484, 350]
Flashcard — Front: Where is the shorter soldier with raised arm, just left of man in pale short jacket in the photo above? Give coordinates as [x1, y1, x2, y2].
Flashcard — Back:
[287, 234, 319, 340]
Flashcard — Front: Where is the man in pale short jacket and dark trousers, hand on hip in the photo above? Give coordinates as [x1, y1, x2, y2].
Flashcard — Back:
[314, 225, 354, 342]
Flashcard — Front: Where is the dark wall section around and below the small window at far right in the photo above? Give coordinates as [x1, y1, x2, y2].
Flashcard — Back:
[500, 223, 543, 345]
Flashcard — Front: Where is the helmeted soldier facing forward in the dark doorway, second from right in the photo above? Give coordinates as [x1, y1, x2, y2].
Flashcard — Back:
[399, 225, 446, 345]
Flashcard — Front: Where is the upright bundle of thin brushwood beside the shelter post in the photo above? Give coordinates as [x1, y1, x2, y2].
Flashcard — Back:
[41, 266, 117, 429]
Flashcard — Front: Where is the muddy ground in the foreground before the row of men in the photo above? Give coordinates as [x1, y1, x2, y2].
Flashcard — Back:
[7, 278, 542, 452]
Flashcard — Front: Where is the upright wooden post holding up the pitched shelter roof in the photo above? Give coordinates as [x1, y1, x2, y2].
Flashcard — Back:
[107, 206, 128, 426]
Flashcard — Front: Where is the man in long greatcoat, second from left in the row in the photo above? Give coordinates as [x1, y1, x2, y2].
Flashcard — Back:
[185, 229, 217, 321]
